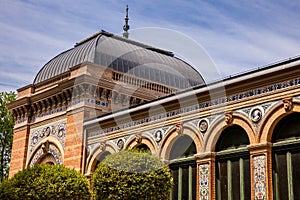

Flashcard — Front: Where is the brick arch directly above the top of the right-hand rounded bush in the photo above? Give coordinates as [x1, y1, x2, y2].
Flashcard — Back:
[125, 135, 157, 155]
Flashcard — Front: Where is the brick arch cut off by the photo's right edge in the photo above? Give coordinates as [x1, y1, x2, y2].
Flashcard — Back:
[258, 99, 300, 143]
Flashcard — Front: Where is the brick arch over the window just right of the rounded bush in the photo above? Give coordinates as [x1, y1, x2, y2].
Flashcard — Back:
[159, 124, 203, 160]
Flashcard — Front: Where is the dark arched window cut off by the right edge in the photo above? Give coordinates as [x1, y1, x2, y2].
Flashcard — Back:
[272, 113, 300, 199]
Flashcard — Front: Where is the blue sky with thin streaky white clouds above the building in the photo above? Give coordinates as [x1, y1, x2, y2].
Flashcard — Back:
[0, 0, 300, 92]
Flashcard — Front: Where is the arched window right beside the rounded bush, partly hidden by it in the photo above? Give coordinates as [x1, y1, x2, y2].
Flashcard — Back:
[169, 135, 197, 200]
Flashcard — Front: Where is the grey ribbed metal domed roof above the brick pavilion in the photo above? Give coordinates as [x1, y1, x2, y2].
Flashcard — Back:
[34, 31, 205, 89]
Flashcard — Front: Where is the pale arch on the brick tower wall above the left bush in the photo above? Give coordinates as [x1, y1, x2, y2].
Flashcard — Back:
[26, 136, 64, 167]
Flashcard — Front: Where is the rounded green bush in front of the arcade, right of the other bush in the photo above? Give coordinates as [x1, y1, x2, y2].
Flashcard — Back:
[92, 150, 173, 200]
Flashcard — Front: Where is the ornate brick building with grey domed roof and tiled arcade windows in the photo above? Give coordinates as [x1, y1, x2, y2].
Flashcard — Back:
[9, 27, 300, 199]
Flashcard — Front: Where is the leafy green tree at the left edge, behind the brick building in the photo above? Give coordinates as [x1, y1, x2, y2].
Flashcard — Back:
[0, 92, 16, 183]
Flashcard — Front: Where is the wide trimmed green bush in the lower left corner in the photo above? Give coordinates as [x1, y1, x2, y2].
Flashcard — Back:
[0, 164, 91, 200]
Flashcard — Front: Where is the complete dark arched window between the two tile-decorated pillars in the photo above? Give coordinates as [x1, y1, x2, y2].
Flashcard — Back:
[216, 125, 251, 200]
